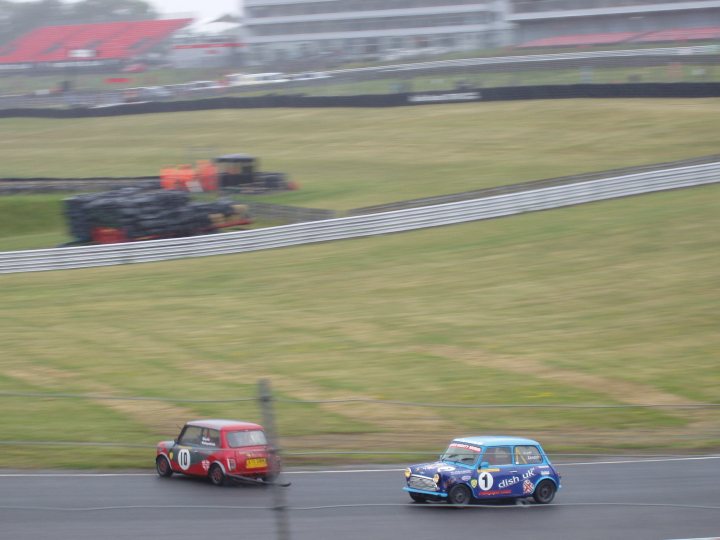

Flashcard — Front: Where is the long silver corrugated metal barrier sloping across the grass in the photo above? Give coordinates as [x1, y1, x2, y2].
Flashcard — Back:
[0, 162, 720, 273]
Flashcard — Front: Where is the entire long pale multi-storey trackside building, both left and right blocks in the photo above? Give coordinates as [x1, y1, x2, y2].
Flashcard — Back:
[244, 0, 720, 65]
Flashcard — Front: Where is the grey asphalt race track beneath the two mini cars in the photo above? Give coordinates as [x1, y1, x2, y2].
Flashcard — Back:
[0, 456, 720, 540]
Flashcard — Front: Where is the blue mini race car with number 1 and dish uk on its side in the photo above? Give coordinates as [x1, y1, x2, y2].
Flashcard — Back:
[403, 436, 561, 505]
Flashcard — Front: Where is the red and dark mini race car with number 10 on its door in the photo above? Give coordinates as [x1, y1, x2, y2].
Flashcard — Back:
[155, 420, 280, 486]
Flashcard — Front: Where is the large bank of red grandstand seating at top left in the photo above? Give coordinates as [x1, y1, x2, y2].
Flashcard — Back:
[0, 19, 192, 64]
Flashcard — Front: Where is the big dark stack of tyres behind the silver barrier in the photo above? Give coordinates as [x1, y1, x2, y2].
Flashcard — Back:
[65, 188, 250, 242]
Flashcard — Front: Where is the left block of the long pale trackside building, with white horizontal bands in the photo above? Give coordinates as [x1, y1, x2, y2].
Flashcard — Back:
[245, 0, 511, 64]
